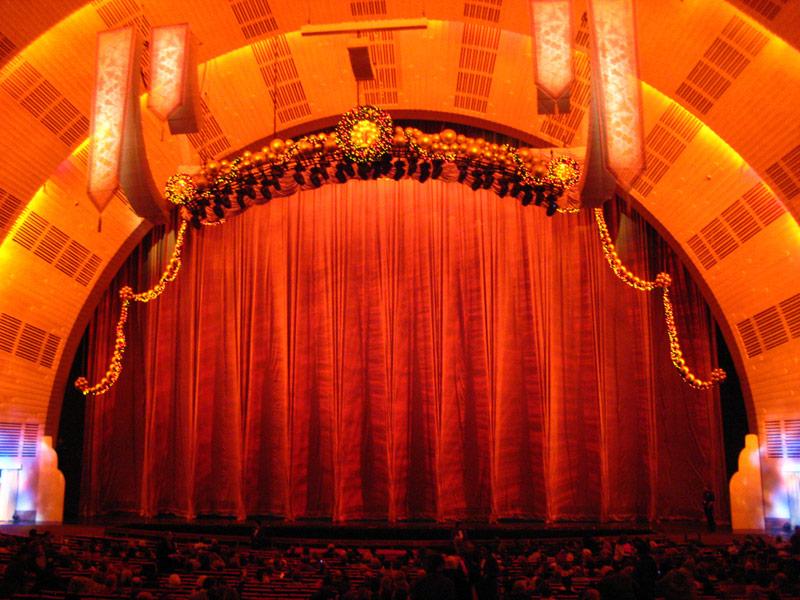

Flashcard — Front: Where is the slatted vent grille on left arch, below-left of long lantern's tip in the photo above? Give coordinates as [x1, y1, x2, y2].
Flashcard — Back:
[12, 211, 103, 287]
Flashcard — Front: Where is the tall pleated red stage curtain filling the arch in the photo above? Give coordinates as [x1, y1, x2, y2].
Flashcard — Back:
[82, 181, 724, 521]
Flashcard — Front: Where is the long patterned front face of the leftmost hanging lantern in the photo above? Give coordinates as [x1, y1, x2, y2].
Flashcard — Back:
[88, 27, 138, 212]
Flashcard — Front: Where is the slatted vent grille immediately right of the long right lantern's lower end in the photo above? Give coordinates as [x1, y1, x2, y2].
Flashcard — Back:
[631, 104, 703, 197]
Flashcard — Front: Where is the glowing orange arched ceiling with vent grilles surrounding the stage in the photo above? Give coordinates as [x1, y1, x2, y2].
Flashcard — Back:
[0, 0, 800, 446]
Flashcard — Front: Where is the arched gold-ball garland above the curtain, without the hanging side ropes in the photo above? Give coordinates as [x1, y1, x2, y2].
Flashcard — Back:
[167, 106, 581, 227]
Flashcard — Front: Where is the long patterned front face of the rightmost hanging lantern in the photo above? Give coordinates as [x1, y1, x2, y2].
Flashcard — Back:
[589, 0, 644, 182]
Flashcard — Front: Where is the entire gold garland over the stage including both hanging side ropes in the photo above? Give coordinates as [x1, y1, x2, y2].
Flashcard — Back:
[75, 106, 726, 396]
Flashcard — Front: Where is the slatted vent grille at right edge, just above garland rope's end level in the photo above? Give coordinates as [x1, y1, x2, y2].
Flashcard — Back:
[736, 293, 800, 358]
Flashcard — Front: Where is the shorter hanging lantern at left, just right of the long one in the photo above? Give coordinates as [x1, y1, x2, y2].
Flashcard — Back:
[147, 23, 198, 134]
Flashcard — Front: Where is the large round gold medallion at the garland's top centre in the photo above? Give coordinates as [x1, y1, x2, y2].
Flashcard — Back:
[334, 105, 393, 163]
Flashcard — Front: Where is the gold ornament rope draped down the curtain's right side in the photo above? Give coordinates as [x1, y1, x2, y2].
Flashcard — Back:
[594, 208, 727, 390]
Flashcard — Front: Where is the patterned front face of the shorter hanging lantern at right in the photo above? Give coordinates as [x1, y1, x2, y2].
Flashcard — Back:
[531, 0, 573, 100]
